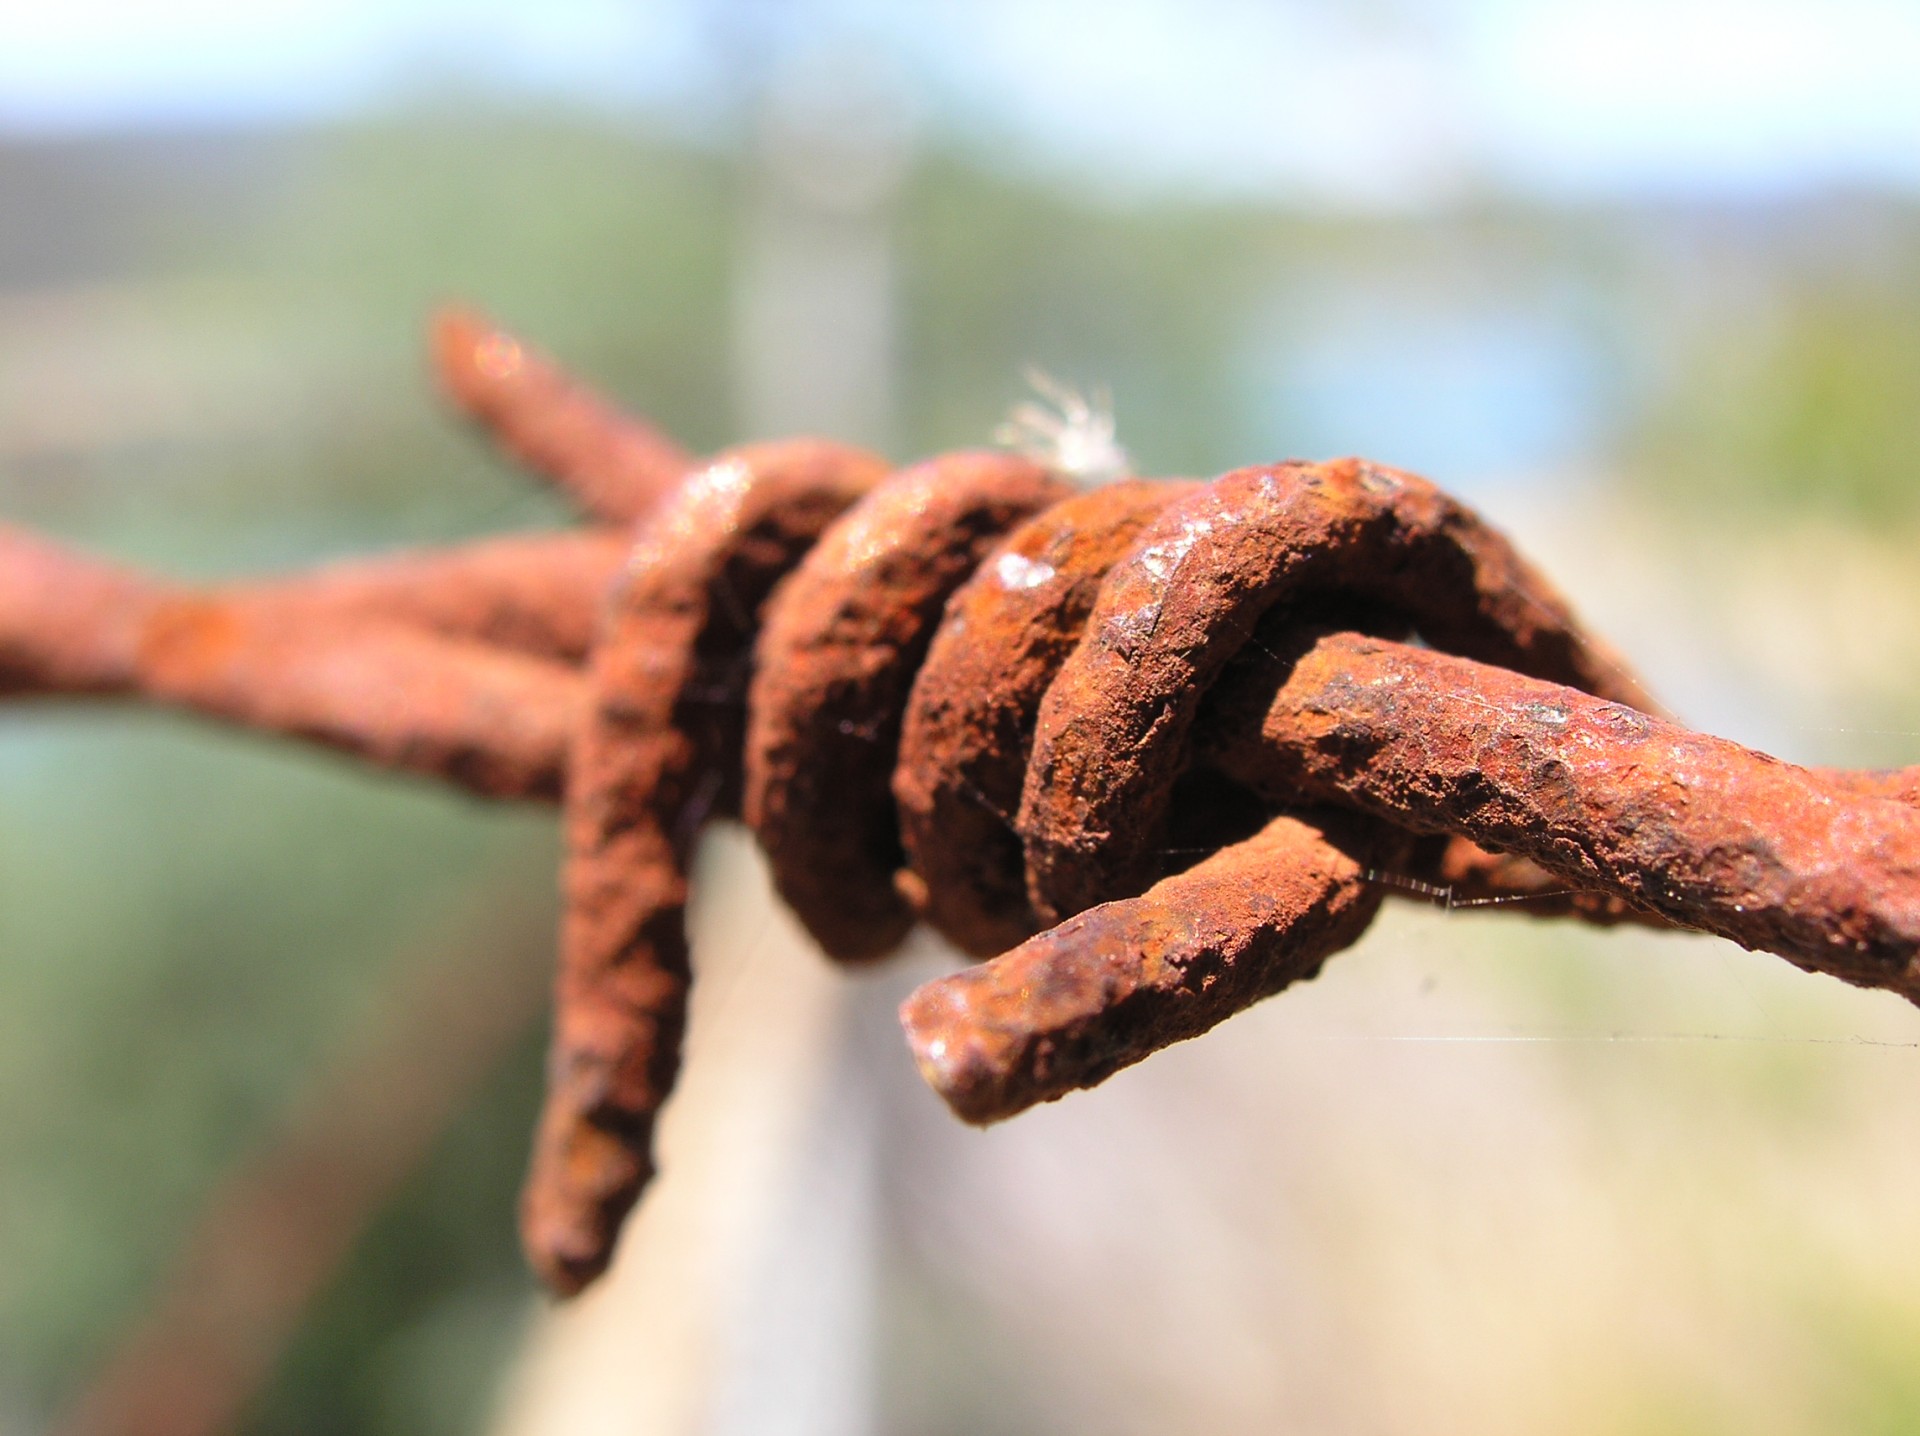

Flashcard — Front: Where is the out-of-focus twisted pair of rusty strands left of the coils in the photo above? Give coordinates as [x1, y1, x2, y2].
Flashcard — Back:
[0, 528, 579, 801]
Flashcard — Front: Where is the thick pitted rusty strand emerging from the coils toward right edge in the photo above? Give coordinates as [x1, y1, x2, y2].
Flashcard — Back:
[1212, 634, 1920, 1000]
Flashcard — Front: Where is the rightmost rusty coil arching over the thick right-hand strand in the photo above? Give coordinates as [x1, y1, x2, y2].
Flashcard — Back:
[1020, 459, 1647, 921]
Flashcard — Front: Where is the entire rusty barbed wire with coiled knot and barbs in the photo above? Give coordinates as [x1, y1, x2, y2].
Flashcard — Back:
[0, 315, 1920, 1292]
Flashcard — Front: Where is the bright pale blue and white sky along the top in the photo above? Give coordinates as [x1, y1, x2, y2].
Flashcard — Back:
[0, 0, 1920, 207]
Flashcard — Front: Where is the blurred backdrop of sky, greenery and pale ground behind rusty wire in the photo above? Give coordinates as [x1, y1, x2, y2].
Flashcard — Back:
[0, 0, 1920, 1436]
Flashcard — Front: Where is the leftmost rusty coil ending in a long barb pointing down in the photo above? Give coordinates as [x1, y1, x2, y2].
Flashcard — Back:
[520, 440, 887, 1292]
